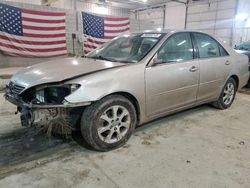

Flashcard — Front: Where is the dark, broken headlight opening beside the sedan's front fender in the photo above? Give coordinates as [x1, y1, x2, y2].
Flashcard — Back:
[33, 84, 80, 104]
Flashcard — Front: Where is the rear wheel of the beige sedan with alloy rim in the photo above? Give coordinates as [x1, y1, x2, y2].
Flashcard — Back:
[213, 78, 237, 110]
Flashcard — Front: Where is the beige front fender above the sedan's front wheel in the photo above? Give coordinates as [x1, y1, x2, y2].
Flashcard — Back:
[65, 63, 147, 123]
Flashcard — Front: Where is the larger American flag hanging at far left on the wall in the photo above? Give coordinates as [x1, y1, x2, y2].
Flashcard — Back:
[0, 3, 67, 58]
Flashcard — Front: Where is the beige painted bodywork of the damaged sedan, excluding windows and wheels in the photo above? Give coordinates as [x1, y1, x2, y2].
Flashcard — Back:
[5, 31, 249, 128]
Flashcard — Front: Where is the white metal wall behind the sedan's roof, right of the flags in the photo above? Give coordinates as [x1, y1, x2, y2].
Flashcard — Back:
[131, 0, 238, 45]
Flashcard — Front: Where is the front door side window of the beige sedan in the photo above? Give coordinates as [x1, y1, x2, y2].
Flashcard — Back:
[157, 33, 194, 63]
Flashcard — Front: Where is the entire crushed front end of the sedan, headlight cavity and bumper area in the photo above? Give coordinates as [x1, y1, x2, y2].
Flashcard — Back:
[5, 81, 89, 132]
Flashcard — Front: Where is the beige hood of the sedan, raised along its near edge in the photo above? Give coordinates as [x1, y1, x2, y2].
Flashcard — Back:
[11, 58, 124, 88]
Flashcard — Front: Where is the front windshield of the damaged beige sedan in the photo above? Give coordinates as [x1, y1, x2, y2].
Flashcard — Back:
[87, 33, 164, 63]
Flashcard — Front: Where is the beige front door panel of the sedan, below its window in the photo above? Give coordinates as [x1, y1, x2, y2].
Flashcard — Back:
[145, 60, 199, 116]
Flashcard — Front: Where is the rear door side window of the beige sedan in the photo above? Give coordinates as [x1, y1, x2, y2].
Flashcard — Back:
[194, 33, 220, 58]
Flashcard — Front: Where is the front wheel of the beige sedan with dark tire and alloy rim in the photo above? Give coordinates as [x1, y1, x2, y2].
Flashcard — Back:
[81, 95, 137, 151]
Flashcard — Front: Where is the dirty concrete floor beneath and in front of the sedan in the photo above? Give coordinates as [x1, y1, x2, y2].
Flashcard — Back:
[0, 92, 250, 188]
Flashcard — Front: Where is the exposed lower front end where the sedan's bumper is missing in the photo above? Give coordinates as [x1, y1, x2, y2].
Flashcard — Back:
[5, 91, 91, 129]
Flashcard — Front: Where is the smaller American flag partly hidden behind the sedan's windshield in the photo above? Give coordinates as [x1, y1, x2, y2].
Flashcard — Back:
[82, 12, 129, 54]
